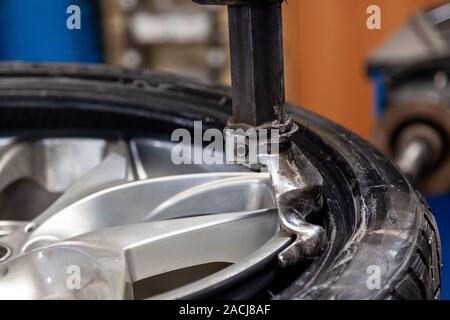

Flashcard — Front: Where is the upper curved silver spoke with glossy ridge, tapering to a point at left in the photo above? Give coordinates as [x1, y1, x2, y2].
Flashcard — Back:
[21, 173, 274, 250]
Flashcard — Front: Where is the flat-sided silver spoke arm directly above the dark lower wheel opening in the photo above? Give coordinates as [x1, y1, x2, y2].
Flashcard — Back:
[72, 210, 278, 281]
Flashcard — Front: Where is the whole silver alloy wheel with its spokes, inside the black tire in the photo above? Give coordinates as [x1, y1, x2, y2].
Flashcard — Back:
[0, 139, 292, 299]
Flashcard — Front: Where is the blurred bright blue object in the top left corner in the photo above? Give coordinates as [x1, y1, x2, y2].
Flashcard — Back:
[0, 0, 102, 63]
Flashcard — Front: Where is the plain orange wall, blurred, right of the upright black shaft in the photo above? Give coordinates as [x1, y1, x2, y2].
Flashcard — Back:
[283, 0, 442, 137]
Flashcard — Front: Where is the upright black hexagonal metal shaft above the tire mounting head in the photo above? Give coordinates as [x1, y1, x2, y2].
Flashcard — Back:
[194, 0, 285, 126]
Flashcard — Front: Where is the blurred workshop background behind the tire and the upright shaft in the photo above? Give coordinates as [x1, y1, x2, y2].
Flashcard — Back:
[0, 0, 450, 298]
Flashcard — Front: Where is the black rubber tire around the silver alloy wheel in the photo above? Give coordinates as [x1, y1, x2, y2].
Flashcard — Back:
[0, 63, 441, 299]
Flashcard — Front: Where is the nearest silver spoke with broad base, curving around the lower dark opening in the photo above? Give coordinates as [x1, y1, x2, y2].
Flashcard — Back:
[0, 210, 290, 299]
